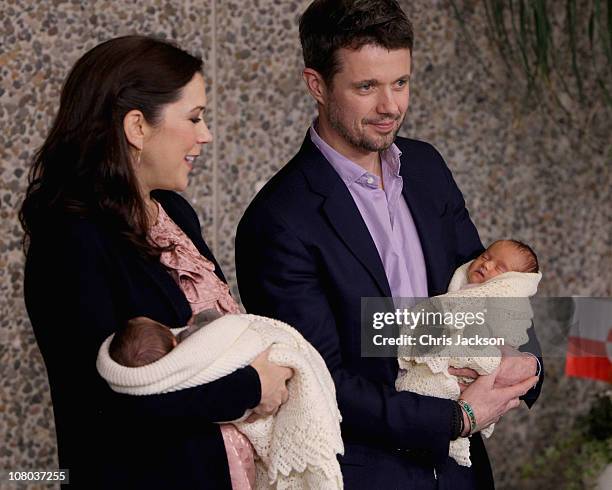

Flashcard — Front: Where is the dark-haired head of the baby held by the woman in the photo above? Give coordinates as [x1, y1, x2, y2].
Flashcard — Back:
[109, 316, 177, 367]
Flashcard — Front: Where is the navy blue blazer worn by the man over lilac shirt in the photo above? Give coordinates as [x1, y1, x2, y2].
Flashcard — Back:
[236, 135, 544, 489]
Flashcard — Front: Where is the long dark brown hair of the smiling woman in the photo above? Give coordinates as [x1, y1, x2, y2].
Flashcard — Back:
[19, 36, 202, 258]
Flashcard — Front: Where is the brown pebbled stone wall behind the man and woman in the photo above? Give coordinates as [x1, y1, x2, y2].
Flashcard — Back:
[0, 0, 612, 489]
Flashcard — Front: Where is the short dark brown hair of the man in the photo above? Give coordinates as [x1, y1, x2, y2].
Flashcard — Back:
[300, 0, 414, 87]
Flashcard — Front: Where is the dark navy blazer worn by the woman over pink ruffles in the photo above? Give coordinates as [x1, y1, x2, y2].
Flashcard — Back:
[25, 191, 261, 489]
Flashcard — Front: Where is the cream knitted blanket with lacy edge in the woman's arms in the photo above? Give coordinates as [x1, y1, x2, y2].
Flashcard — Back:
[97, 315, 344, 489]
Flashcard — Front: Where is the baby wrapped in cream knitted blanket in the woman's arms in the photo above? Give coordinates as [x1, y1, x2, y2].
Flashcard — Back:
[96, 313, 343, 490]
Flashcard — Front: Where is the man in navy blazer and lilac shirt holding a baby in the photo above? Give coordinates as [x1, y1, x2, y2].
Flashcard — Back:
[236, 0, 539, 489]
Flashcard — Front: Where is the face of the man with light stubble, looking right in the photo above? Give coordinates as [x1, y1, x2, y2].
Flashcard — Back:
[323, 44, 411, 154]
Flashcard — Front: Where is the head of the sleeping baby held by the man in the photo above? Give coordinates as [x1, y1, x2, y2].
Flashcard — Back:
[468, 240, 539, 284]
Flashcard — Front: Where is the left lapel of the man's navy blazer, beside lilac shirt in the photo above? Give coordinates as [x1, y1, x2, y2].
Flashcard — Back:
[300, 134, 391, 296]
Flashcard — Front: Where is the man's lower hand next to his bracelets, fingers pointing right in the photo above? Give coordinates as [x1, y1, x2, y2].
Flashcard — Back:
[461, 368, 538, 435]
